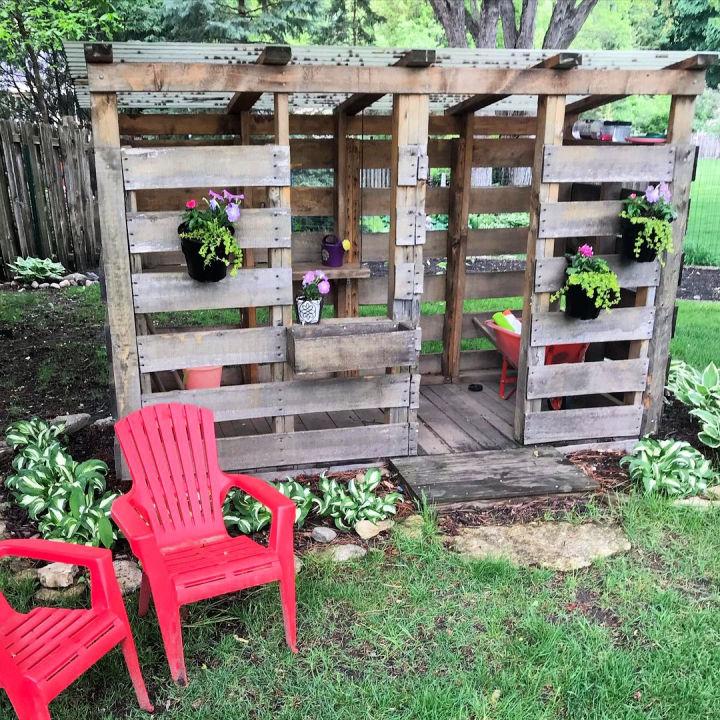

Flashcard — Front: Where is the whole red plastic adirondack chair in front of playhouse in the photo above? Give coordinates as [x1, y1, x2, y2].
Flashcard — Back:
[112, 403, 297, 684]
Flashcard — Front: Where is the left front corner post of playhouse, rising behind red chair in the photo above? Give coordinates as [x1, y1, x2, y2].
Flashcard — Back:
[90, 93, 140, 424]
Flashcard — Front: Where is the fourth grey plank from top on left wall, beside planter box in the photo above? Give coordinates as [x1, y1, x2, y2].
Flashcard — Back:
[138, 327, 286, 373]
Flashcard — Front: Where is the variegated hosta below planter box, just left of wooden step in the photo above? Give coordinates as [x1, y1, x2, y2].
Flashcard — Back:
[317, 468, 401, 530]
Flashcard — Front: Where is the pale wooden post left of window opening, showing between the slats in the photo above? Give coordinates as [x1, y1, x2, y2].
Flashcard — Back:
[268, 93, 294, 432]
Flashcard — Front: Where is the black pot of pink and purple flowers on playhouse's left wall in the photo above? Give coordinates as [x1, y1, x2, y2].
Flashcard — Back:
[178, 190, 245, 280]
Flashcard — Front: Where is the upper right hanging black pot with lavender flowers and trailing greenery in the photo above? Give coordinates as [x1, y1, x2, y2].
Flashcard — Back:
[620, 182, 677, 262]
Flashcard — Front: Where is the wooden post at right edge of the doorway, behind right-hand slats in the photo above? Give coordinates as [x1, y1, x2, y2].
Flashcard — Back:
[515, 95, 565, 442]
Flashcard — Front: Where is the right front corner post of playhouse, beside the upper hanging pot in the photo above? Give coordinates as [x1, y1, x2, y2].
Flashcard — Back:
[640, 96, 695, 435]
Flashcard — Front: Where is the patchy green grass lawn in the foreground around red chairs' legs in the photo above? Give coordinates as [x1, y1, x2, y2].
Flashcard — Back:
[0, 498, 720, 720]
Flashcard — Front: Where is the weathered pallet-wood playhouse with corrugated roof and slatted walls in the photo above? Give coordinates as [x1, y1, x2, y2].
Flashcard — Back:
[66, 43, 715, 506]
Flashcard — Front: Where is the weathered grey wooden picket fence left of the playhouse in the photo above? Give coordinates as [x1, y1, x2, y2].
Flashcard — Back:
[0, 120, 100, 278]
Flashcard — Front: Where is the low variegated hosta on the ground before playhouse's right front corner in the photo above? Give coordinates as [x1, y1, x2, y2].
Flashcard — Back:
[620, 437, 716, 496]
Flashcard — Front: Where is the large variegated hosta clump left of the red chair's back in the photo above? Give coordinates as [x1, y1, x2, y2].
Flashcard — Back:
[5, 418, 117, 547]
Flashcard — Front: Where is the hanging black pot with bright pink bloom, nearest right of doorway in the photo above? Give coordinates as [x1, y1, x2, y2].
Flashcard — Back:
[550, 245, 620, 320]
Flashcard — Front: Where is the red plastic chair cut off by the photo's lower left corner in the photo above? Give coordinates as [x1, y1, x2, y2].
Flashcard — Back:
[0, 540, 153, 720]
